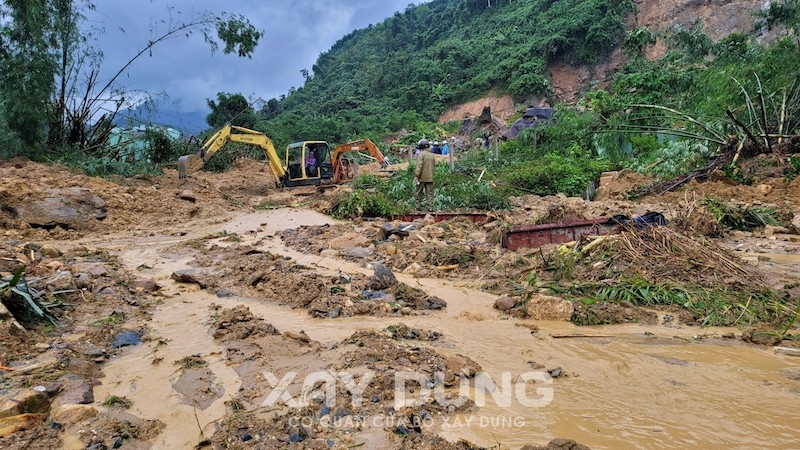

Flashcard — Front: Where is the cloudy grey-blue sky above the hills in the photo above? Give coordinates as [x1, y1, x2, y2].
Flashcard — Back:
[86, 0, 412, 131]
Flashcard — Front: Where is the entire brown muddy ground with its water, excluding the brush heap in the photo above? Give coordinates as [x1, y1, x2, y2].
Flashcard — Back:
[0, 156, 800, 449]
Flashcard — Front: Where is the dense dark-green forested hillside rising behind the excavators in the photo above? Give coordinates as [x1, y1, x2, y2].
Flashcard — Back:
[253, 0, 633, 142]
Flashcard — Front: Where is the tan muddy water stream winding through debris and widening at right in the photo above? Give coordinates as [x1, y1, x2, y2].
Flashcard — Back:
[76, 210, 800, 449]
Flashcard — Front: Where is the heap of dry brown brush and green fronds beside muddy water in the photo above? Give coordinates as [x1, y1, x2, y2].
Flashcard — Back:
[540, 227, 796, 325]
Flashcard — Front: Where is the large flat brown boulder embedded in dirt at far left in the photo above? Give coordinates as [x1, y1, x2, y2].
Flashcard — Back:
[9, 187, 106, 228]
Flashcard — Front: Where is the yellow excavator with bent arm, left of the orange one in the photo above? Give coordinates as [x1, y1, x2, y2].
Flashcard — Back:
[178, 124, 333, 187]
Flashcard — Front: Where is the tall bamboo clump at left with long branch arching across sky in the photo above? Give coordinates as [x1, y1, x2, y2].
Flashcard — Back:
[0, 0, 263, 155]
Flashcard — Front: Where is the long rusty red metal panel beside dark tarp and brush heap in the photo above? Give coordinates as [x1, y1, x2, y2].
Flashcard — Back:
[503, 219, 621, 250]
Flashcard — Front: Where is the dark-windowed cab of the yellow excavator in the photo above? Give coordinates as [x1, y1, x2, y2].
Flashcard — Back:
[286, 141, 333, 185]
